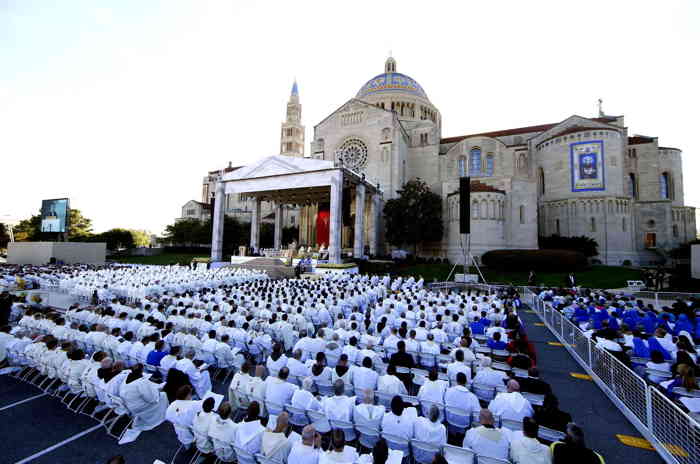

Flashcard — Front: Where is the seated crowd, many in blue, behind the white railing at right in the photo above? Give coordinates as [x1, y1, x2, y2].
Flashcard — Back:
[539, 289, 700, 413]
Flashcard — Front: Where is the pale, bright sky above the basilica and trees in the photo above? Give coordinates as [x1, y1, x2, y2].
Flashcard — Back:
[0, 0, 700, 233]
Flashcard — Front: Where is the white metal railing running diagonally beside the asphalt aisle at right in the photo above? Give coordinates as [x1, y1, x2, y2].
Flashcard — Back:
[522, 288, 700, 464]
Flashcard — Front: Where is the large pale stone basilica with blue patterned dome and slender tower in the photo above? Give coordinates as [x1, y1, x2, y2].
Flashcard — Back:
[196, 57, 696, 264]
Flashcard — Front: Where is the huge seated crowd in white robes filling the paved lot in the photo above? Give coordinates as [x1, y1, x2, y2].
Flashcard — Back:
[0, 267, 602, 464]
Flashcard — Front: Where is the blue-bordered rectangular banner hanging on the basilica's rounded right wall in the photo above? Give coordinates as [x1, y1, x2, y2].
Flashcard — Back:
[569, 140, 605, 192]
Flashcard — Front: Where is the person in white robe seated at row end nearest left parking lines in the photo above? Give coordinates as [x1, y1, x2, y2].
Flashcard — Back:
[119, 364, 168, 431]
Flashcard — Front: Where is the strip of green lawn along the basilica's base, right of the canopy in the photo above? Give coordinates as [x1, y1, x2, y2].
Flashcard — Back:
[396, 264, 641, 288]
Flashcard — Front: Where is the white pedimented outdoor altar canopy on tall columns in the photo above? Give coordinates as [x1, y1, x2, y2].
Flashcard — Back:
[211, 155, 382, 264]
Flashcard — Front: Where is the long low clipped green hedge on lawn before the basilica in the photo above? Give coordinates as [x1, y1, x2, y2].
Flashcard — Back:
[481, 250, 588, 272]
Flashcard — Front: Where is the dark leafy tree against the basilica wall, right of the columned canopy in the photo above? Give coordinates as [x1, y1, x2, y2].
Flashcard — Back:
[384, 178, 443, 255]
